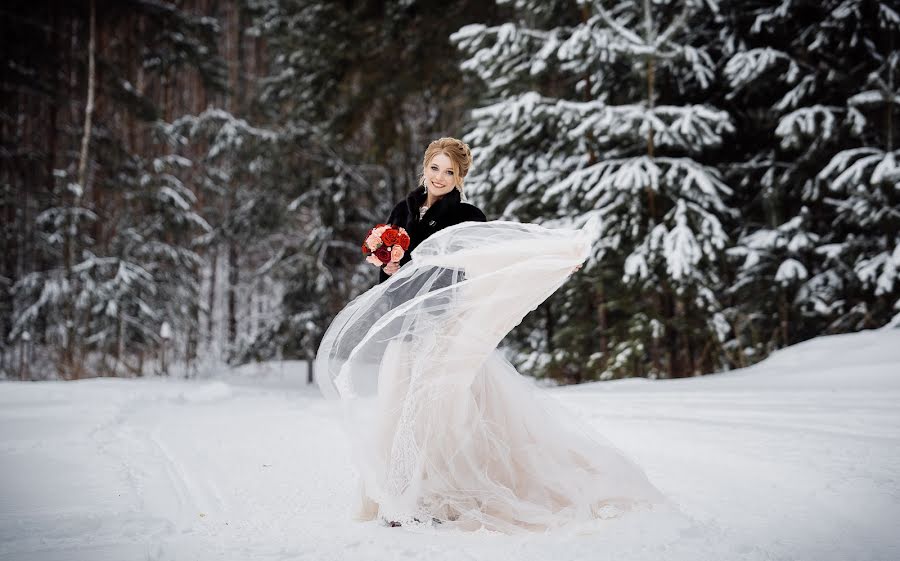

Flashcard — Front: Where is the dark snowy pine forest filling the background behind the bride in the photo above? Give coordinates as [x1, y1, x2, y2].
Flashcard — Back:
[0, 0, 900, 383]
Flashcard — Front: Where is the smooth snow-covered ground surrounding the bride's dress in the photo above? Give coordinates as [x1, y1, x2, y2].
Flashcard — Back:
[0, 329, 900, 561]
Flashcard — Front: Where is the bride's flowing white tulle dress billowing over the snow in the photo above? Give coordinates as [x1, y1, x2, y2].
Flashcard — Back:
[316, 215, 665, 533]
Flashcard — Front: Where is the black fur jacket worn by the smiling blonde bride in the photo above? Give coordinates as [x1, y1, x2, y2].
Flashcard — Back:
[378, 186, 487, 283]
